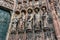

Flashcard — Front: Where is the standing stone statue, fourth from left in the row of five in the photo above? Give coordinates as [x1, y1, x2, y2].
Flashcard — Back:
[34, 7, 41, 28]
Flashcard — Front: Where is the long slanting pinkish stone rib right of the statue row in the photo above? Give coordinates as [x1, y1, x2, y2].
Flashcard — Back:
[50, 0, 60, 40]
